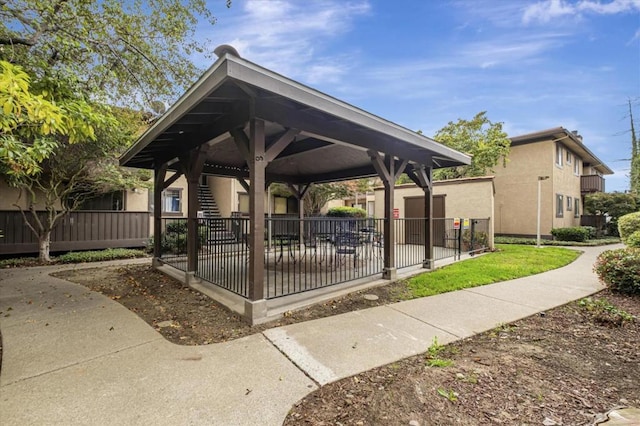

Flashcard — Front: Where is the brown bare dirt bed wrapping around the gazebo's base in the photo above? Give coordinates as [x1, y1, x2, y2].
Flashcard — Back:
[53, 265, 406, 345]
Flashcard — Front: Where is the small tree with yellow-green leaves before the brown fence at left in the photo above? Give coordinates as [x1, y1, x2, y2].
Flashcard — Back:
[0, 61, 146, 262]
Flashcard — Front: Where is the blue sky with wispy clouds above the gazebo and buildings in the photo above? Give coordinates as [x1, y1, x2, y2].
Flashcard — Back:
[195, 0, 640, 191]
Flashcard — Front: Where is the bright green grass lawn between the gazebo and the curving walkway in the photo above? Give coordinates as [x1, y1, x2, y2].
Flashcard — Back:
[404, 244, 580, 299]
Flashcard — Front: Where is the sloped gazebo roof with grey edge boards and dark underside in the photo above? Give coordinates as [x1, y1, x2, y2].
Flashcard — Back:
[120, 49, 470, 183]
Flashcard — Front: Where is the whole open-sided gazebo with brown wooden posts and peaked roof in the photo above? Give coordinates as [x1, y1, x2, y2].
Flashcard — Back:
[120, 45, 470, 323]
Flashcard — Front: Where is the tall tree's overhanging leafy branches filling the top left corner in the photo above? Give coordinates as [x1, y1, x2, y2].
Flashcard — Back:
[0, 0, 224, 105]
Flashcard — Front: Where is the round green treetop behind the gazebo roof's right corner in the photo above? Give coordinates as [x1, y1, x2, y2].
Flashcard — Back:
[433, 111, 511, 180]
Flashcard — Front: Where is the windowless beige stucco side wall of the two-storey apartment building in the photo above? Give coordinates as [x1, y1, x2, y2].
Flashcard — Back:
[494, 141, 555, 235]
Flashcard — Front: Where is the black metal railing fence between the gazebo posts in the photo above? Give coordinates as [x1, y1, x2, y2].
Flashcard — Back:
[161, 217, 489, 299]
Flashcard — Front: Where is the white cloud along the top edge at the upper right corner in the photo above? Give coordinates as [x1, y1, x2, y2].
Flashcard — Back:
[522, 0, 640, 24]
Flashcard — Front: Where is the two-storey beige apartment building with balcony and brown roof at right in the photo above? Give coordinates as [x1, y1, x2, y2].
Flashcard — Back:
[494, 127, 613, 237]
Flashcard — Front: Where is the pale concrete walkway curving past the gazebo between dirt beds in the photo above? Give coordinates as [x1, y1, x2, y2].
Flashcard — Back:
[0, 246, 615, 425]
